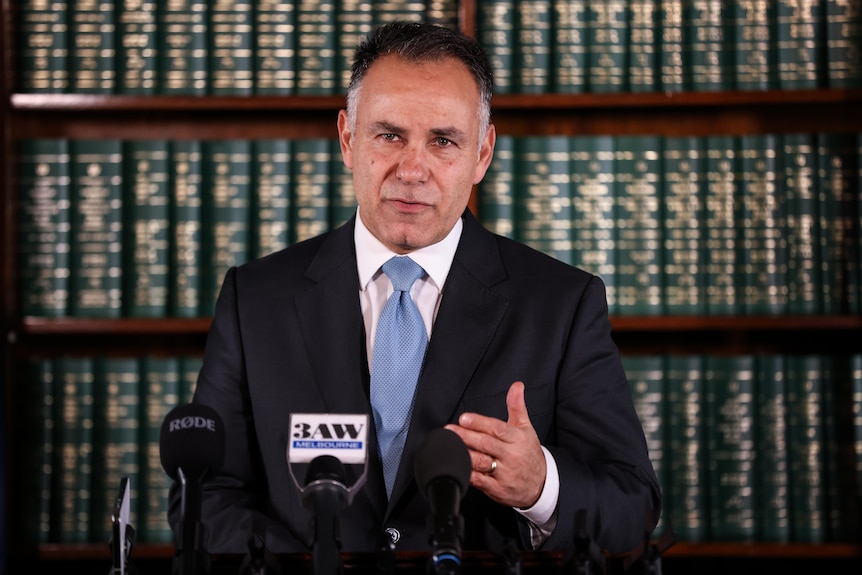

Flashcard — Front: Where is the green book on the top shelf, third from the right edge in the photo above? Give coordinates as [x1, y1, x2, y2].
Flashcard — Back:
[731, 0, 776, 90]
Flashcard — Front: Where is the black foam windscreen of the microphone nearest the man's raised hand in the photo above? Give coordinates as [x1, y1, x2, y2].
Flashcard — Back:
[413, 427, 473, 496]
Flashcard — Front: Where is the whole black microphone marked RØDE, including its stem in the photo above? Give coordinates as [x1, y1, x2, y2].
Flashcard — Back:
[159, 403, 225, 575]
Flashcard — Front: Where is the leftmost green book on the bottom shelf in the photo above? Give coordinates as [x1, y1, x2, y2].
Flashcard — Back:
[20, 357, 56, 545]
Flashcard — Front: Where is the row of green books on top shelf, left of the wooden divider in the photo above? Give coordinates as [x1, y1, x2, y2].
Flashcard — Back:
[18, 0, 458, 96]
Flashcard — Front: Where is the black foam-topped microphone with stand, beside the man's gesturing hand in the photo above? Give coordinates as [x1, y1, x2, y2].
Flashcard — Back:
[414, 428, 472, 575]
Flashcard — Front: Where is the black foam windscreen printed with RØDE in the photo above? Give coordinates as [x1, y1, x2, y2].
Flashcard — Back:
[159, 403, 225, 479]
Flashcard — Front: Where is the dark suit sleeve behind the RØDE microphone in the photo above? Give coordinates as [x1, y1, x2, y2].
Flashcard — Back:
[168, 268, 306, 553]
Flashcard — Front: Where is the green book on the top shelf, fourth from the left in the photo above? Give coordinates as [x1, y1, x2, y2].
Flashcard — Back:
[157, 0, 209, 96]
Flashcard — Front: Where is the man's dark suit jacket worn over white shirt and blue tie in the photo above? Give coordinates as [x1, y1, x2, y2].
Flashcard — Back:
[169, 212, 660, 553]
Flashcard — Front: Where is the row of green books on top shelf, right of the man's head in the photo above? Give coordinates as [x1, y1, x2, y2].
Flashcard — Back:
[476, 0, 862, 93]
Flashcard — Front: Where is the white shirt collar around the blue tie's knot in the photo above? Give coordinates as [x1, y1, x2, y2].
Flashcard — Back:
[353, 208, 464, 291]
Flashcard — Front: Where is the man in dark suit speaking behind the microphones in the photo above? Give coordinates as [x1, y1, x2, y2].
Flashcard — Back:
[170, 24, 660, 564]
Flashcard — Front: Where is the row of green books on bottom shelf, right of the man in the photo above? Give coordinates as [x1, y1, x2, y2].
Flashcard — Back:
[623, 354, 862, 543]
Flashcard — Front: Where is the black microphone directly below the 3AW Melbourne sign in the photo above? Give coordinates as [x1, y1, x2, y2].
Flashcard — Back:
[302, 455, 348, 575]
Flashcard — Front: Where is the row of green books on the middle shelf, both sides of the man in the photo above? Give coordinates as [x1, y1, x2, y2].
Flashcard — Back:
[18, 133, 862, 317]
